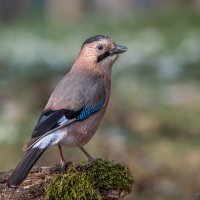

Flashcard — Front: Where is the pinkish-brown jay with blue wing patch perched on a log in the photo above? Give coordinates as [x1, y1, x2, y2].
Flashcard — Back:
[8, 35, 127, 188]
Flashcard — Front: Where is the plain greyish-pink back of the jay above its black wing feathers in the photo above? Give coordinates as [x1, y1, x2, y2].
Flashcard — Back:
[45, 67, 110, 111]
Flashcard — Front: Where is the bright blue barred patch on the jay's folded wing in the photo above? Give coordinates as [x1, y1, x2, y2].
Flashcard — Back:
[76, 99, 105, 121]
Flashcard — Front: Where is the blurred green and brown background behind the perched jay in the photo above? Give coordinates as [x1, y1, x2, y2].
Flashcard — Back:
[0, 0, 200, 200]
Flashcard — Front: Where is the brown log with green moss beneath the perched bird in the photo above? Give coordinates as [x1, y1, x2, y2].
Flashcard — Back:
[0, 159, 134, 200]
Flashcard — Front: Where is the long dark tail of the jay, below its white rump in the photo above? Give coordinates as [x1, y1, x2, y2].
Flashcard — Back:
[8, 148, 46, 188]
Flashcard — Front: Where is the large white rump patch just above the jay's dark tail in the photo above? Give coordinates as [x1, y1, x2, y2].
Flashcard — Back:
[33, 130, 64, 149]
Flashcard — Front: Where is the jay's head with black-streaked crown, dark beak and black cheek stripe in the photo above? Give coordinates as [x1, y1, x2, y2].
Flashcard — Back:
[74, 35, 127, 73]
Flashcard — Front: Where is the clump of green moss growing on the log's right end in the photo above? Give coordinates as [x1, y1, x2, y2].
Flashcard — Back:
[45, 159, 134, 200]
